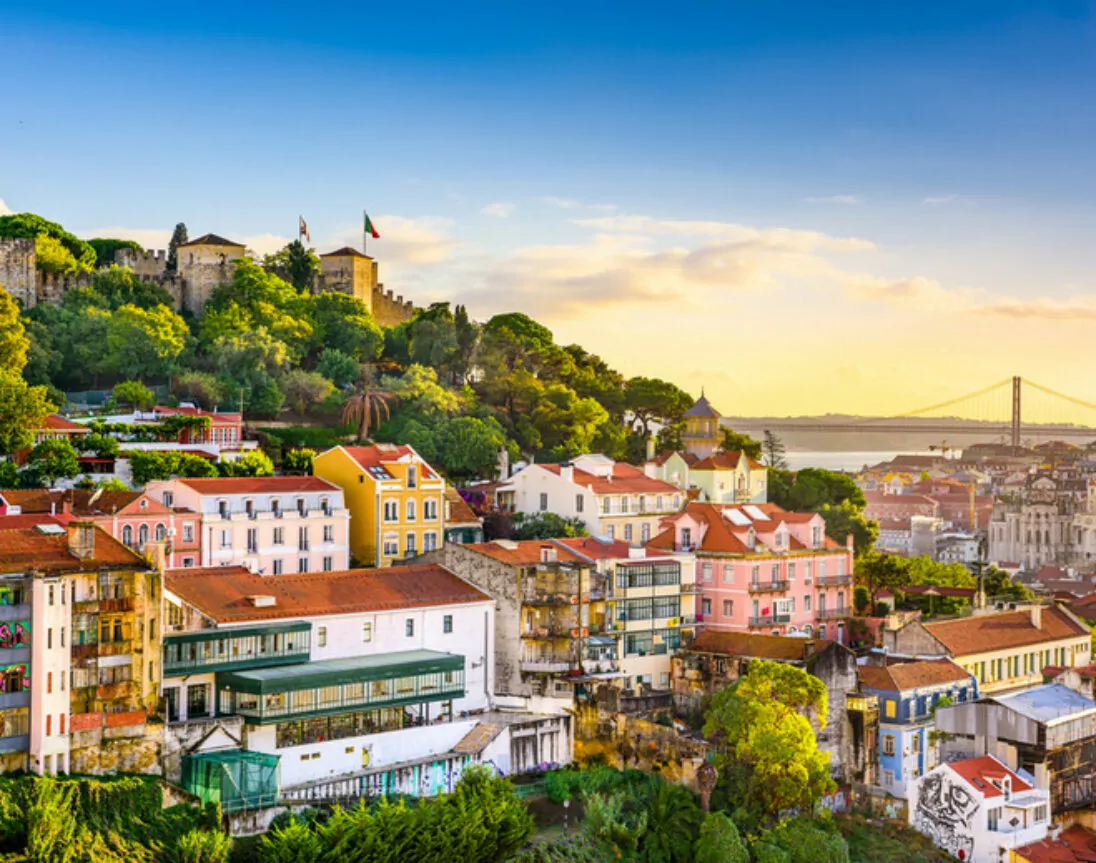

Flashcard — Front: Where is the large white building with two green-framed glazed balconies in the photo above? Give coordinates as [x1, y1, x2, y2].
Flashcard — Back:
[162, 565, 501, 787]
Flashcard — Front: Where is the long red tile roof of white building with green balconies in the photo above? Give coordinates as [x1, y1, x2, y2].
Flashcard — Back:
[163, 564, 491, 623]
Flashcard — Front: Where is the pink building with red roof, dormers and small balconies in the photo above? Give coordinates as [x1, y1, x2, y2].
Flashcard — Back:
[650, 503, 853, 643]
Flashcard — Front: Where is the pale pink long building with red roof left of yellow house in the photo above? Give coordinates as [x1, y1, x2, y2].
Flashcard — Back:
[146, 476, 350, 576]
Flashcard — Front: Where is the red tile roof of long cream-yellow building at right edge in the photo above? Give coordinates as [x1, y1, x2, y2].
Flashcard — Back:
[924, 605, 1089, 656]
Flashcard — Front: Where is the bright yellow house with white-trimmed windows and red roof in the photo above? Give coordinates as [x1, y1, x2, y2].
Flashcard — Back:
[312, 443, 445, 566]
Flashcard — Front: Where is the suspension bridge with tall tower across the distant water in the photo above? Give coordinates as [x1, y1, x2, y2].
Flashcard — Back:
[731, 376, 1096, 447]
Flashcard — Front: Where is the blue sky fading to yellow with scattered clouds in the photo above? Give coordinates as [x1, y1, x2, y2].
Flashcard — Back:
[0, 0, 1096, 413]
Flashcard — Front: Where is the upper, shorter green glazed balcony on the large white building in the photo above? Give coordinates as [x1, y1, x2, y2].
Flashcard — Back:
[163, 622, 311, 677]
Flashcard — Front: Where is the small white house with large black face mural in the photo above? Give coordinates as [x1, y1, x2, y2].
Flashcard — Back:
[909, 756, 1050, 863]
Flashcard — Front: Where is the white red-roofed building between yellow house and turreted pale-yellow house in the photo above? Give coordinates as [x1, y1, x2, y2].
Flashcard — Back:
[496, 455, 684, 543]
